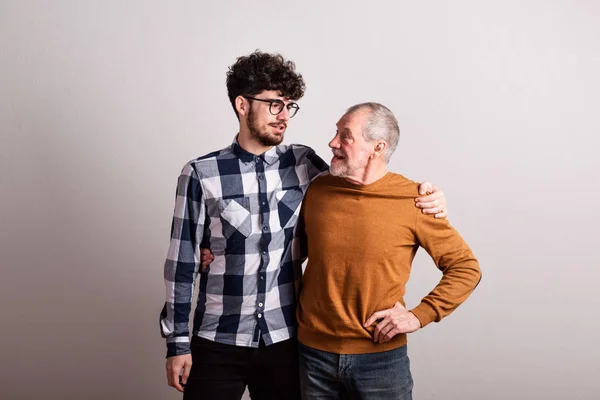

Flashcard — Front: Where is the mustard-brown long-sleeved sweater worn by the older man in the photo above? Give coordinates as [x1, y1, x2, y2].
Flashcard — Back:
[297, 172, 481, 354]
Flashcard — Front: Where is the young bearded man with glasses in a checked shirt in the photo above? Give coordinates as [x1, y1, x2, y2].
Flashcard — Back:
[160, 51, 446, 399]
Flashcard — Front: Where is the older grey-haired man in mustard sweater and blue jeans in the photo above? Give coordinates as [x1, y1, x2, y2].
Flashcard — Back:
[298, 103, 481, 400]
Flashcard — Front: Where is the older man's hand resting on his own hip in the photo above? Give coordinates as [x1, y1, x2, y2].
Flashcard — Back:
[364, 302, 421, 343]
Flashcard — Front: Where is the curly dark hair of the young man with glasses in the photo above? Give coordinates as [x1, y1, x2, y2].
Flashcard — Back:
[227, 50, 306, 119]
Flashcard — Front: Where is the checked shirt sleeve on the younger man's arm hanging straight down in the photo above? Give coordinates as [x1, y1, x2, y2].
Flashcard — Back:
[160, 163, 206, 357]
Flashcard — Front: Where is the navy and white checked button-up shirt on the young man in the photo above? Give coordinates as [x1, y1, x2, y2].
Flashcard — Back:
[160, 140, 328, 357]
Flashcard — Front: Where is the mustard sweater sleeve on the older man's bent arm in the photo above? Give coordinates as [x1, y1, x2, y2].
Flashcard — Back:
[411, 211, 481, 327]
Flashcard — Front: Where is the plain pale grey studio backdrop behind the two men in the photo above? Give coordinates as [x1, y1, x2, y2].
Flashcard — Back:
[0, 0, 600, 400]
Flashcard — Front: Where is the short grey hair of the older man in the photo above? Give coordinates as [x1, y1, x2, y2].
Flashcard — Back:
[346, 102, 400, 164]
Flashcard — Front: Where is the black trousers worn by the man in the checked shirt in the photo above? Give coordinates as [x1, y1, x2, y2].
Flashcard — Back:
[183, 336, 300, 400]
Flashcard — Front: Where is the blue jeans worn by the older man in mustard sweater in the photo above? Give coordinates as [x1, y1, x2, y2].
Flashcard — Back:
[298, 343, 413, 400]
